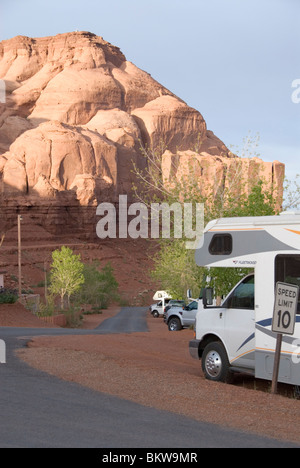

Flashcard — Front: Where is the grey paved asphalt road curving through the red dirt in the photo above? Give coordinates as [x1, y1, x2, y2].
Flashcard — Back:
[0, 308, 294, 449]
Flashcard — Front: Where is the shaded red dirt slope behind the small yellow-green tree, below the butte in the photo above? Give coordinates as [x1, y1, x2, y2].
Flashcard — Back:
[0, 220, 157, 305]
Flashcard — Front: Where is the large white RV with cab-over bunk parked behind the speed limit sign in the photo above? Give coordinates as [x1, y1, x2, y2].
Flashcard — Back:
[189, 212, 300, 385]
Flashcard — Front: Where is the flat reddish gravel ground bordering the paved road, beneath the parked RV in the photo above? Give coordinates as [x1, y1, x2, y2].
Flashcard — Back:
[0, 304, 300, 443]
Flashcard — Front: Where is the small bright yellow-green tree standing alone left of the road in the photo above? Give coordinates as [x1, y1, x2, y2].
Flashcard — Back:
[49, 246, 84, 309]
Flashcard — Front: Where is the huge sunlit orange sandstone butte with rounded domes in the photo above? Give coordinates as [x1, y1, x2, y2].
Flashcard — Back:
[0, 31, 284, 238]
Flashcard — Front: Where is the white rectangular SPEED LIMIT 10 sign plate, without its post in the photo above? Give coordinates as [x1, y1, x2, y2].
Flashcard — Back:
[272, 282, 299, 335]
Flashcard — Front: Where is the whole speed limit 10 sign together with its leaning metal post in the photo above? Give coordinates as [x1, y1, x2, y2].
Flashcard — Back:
[271, 282, 299, 394]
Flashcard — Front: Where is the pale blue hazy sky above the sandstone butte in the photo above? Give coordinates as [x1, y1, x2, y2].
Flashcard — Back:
[0, 0, 300, 180]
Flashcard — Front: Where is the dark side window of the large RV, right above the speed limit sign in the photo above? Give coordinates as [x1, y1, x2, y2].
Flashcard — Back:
[275, 255, 300, 314]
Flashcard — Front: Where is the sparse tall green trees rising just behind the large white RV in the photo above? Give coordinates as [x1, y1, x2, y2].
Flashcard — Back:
[133, 135, 300, 299]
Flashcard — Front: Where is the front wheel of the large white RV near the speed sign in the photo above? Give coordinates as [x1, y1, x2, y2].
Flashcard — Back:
[202, 341, 231, 382]
